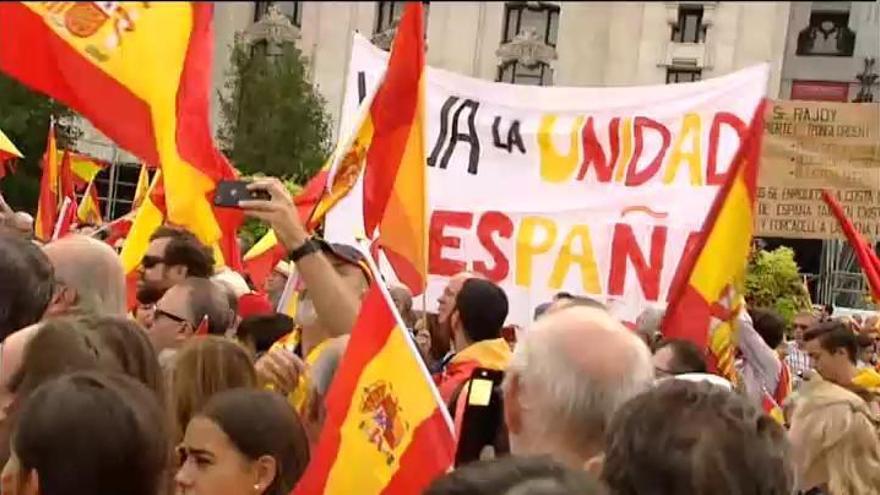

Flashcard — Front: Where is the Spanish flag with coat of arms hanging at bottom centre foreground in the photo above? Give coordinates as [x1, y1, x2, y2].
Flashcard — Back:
[293, 283, 455, 495]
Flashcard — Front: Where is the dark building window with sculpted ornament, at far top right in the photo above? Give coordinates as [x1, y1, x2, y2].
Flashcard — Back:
[796, 6, 856, 57]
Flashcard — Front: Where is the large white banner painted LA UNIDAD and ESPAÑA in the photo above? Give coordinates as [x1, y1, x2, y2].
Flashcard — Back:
[326, 35, 768, 325]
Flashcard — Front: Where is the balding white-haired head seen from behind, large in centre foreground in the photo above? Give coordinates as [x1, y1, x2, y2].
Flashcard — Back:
[504, 306, 654, 468]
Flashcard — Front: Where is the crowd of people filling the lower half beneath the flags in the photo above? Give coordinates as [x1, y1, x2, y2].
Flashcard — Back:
[0, 179, 880, 495]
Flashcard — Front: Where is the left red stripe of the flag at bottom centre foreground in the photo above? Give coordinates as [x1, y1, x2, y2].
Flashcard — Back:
[293, 286, 397, 495]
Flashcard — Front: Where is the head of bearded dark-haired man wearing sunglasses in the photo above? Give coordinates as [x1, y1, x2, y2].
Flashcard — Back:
[138, 227, 214, 292]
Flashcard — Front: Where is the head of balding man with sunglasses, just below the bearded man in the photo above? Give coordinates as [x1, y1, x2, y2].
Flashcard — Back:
[147, 278, 232, 363]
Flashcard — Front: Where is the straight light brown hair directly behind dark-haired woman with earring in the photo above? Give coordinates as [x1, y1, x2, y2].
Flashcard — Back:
[171, 335, 257, 440]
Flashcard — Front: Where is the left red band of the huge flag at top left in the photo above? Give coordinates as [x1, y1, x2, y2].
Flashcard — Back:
[0, 2, 159, 163]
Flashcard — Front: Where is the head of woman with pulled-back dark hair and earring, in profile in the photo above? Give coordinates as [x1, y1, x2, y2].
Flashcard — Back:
[175, 389, 309, 495]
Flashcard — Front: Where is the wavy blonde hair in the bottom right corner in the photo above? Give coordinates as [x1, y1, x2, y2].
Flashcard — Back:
[791, 380, 880, 495]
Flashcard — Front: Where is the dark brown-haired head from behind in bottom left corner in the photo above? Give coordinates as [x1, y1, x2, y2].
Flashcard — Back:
[0, 372, 171, 495]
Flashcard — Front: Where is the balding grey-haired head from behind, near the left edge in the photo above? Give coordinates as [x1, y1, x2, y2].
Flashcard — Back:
[43, 235, 126, 315]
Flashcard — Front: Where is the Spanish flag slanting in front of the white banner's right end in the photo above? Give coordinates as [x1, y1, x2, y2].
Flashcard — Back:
[663, 105, 764, 383]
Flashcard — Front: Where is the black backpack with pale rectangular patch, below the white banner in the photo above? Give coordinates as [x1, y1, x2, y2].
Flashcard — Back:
[455, 368, 510, 466]
